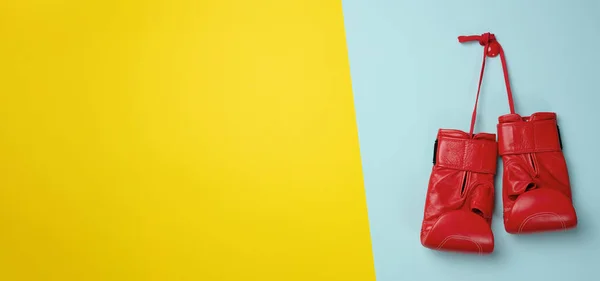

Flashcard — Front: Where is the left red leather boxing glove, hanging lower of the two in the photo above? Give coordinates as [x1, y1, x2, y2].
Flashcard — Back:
[421, 129, 497, 254]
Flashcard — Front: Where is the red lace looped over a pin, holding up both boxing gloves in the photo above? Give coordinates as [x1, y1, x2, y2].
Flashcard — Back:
[458, 32, 515, 137]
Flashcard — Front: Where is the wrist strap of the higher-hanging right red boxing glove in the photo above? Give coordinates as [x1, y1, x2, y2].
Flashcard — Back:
[498, 117, 561, 155]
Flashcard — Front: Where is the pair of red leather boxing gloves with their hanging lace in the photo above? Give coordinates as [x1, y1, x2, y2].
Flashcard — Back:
[421, 33, 577, 254]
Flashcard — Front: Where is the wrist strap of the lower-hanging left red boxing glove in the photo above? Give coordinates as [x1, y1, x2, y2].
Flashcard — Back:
[436, 137, 497, 174]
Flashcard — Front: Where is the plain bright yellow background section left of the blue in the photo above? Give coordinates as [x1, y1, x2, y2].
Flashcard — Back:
[0, 0, 374, 281]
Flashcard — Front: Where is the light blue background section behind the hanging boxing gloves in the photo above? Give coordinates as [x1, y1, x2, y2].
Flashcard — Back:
[343, 0, 600, 281]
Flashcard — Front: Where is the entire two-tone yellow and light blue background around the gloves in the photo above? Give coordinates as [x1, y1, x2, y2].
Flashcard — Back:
[0, 0, 600, 281]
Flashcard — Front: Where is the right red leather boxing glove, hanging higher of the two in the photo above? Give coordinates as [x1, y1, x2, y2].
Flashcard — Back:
[498, 112, 577, 233]
